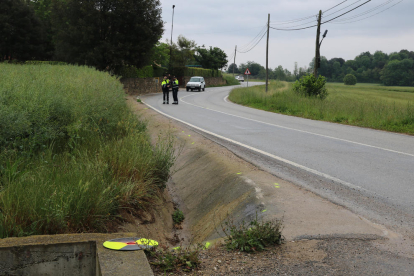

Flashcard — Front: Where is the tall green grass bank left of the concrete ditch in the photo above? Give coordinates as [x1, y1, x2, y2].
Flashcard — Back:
[0, 64, 174, 238]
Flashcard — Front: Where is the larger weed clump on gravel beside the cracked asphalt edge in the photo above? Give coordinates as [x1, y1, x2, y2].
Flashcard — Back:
[222, 213, 283, 252]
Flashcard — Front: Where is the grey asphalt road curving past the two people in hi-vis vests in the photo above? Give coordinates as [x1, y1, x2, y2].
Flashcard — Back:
[142, 83, 414, 237]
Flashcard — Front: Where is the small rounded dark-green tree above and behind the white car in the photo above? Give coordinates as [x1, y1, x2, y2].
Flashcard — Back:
[194, 47, 227, 70]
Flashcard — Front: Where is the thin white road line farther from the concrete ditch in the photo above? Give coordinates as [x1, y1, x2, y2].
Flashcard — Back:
[181, 92, 414, 157]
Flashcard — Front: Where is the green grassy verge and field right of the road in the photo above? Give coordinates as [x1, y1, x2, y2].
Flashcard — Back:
[229, 82, 414, 135]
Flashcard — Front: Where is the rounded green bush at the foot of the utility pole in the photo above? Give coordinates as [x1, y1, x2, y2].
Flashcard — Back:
[293, 74, 328, 100]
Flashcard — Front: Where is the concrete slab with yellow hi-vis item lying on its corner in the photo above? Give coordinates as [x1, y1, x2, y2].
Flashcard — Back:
[0, 233, 153, 276]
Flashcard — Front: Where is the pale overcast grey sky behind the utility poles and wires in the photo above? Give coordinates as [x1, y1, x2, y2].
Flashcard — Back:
[157, 0, 414, 71]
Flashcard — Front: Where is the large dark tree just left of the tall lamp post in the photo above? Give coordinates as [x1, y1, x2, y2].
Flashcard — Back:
[52, 0, 164, 71]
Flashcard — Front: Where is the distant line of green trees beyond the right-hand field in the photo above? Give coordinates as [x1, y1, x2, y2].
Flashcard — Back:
[227, 50, 414, 86]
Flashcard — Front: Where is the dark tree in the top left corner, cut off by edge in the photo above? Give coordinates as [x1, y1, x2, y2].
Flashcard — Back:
[0, 0, 44, 60]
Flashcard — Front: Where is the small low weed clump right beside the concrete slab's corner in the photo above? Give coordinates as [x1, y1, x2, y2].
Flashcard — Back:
[145, 244, 205, 273]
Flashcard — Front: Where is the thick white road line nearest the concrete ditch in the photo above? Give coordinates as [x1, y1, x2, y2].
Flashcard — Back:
[142, 101, 374, 194]
